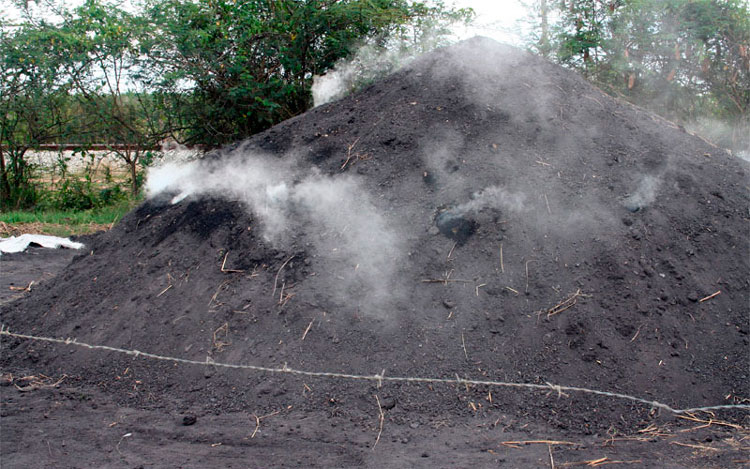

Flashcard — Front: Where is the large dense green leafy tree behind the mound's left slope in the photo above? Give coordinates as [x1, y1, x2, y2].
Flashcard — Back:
[142, 0, 466, 145]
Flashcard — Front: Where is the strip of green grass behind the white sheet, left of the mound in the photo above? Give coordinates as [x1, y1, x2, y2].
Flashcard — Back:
[0, 200, 137, 237]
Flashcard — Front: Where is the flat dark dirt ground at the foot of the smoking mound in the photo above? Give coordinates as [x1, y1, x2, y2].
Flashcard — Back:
[0, 247, 750, 468]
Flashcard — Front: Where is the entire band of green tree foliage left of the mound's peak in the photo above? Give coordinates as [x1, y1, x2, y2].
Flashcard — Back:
[0, 0, 470, 206]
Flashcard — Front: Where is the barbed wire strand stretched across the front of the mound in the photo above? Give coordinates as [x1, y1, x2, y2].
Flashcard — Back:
[0, 325, 750, 414]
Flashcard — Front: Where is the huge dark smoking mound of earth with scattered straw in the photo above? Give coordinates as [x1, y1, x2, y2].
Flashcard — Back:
[2, 39, 750, 446]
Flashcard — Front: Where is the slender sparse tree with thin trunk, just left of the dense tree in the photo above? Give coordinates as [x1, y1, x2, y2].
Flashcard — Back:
[59, 0, 177, 195]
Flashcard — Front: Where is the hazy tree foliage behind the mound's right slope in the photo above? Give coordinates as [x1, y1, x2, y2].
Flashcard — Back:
[533, 0, 750, 149]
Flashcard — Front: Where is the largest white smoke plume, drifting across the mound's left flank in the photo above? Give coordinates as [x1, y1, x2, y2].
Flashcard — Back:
[146, 155, 402, 314]
